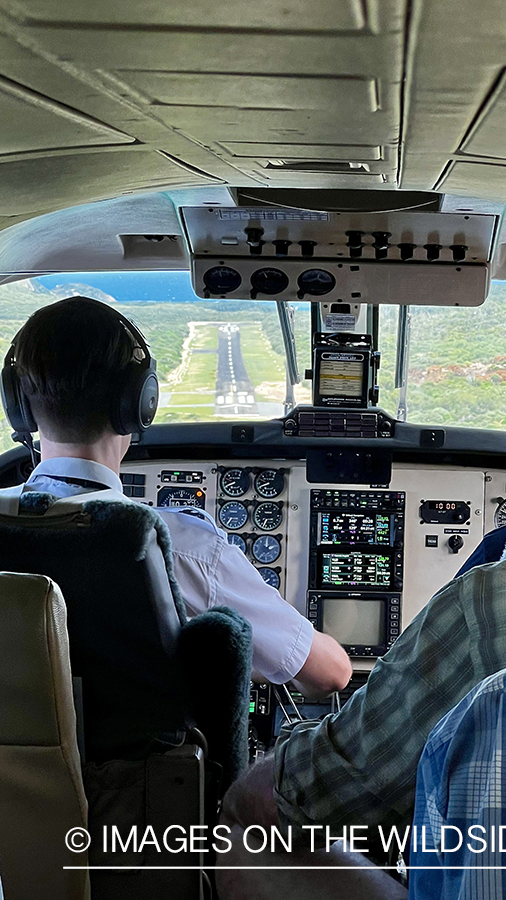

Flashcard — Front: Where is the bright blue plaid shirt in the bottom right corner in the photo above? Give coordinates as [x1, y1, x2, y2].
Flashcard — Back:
[409, 670, 506, 900]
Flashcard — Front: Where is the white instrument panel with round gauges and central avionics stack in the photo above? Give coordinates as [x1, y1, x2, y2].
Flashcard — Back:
[117, 459, 490, 671]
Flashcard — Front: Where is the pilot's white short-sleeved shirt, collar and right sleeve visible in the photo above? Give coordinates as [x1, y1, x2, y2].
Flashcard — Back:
[24, 457, 313, 684]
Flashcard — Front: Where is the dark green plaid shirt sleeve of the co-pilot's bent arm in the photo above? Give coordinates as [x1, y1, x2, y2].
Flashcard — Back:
[275, 562, 506, 836]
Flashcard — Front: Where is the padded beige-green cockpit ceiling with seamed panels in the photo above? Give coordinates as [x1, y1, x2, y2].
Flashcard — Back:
[0, 0, 506, 227]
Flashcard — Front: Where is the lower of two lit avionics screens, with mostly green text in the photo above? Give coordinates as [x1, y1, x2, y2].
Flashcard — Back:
[318, 550, 393, 590]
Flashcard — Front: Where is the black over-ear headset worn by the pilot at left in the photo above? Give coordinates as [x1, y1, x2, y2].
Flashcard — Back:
[0, 297, 158, 445]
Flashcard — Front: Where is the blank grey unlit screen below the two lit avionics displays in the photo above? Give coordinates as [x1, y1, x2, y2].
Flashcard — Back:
[322, 598, 386, 647]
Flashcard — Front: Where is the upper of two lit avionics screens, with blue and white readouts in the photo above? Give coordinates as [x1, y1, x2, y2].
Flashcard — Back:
[317, 510, 395, 546]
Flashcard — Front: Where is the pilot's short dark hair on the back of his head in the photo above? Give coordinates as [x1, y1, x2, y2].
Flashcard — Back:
[16, 297, 135, 444]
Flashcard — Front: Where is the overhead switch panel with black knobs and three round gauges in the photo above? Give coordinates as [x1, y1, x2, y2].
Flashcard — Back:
[180, 207, 499, 306]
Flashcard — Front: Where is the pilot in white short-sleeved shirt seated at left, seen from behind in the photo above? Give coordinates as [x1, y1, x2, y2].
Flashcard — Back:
[2, 297, 352, 695]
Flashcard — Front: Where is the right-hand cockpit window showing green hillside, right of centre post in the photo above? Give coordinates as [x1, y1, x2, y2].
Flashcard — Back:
[379, 281, 506, 429]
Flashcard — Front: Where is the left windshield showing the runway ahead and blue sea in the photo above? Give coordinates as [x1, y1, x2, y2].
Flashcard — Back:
[0, 271, 311, 451]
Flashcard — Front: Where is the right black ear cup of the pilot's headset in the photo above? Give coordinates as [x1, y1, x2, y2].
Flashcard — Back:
[111, 363, 159, 434]
